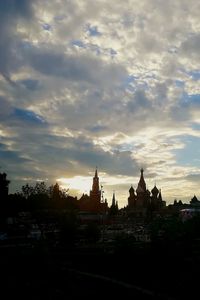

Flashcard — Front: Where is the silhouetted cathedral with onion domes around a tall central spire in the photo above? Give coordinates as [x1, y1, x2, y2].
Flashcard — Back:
[128, 169, 165, 217]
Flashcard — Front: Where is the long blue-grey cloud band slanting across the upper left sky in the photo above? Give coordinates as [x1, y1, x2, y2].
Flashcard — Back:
[23, 47, 126, 85]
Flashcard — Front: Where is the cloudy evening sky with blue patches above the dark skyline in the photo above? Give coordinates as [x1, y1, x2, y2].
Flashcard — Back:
[0, 0, 200, 207]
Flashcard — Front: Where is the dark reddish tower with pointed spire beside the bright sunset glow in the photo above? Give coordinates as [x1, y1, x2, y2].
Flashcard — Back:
[79, 168, 108, 213]
